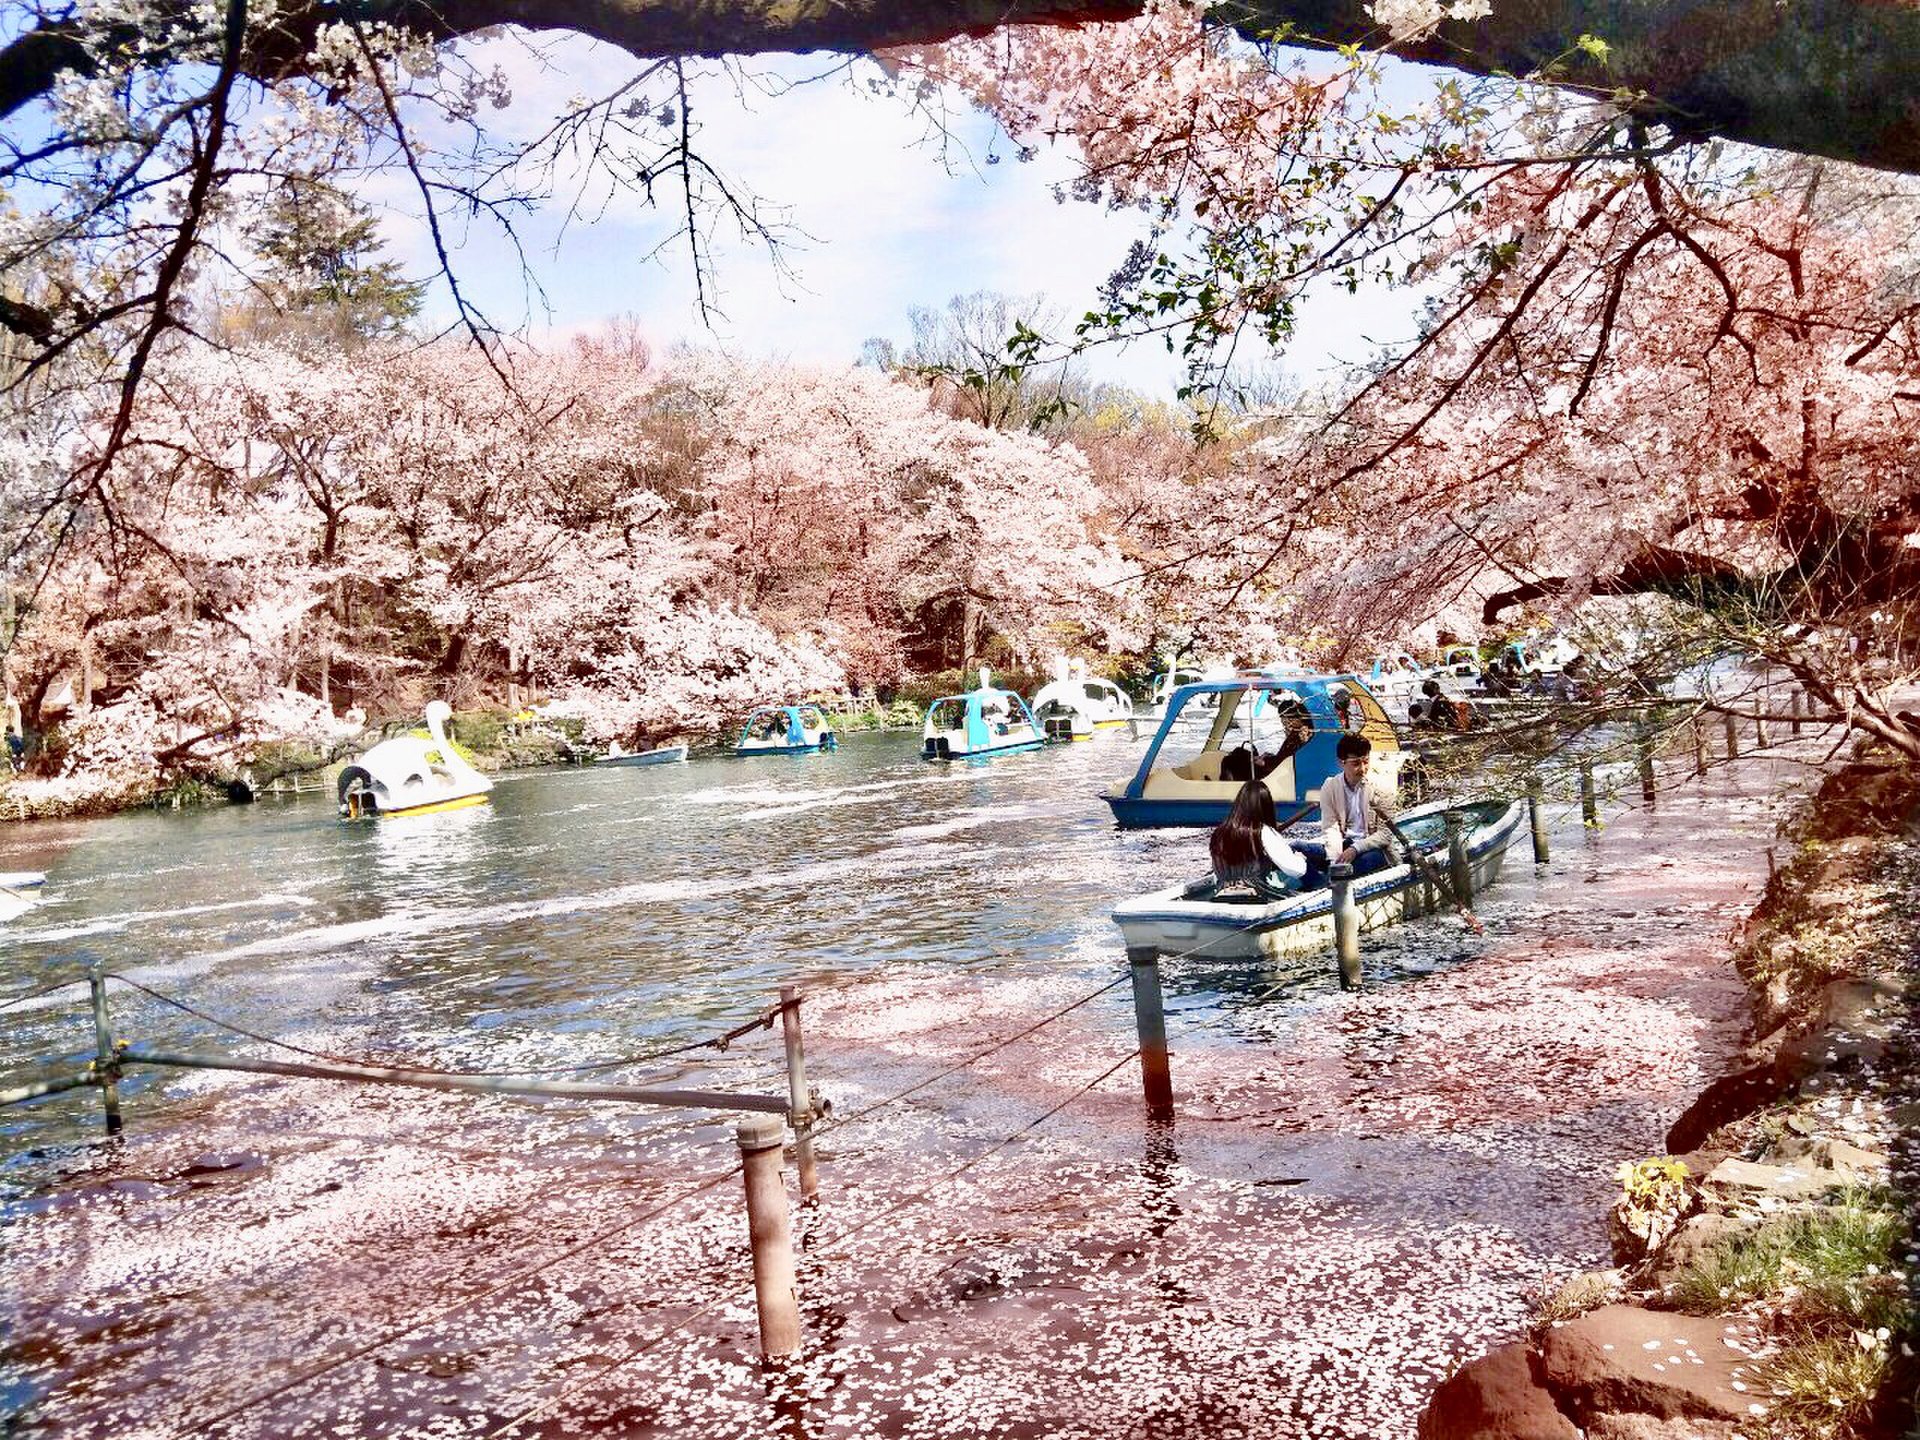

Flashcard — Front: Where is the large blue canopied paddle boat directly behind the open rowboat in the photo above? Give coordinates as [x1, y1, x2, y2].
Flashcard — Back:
[1100, 672, 1407, 829]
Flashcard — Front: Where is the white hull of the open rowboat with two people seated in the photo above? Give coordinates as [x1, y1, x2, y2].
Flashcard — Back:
[1114, 801, 1526, 958]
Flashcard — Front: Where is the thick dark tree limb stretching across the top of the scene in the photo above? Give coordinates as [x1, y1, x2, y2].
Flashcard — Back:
[11, 0, 1920, 173]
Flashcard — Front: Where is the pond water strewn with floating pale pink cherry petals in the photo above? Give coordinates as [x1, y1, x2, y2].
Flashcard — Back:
[0, 735, 1795, 1440]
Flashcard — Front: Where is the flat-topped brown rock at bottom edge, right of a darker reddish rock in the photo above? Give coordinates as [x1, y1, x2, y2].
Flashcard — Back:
[1538, 1306, 1761, 1425]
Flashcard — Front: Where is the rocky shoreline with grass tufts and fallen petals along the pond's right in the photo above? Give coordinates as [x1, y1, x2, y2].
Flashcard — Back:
[1417, 760, 1920, 1440]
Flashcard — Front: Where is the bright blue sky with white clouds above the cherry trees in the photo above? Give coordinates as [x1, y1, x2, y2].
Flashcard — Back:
[378, 36, 1409, 396]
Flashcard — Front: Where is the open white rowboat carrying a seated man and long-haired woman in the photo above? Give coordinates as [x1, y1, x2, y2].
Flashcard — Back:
[1114, 801, 1526, 958]
